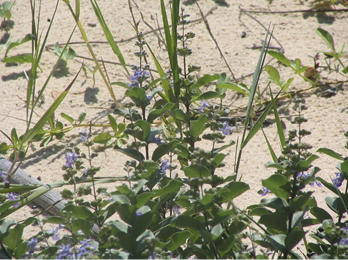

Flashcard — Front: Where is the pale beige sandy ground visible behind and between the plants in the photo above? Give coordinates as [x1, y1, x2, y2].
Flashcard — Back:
[0, 0, 348, 248]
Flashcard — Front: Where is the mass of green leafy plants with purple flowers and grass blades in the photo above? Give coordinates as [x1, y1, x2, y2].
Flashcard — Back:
[0, 0, 348, 260]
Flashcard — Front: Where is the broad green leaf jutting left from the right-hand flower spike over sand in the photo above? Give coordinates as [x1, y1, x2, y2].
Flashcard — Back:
[262, 174, 291, 200]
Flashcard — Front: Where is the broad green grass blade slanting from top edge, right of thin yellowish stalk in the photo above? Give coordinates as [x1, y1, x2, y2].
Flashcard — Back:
[90, 0, 129, 75]
